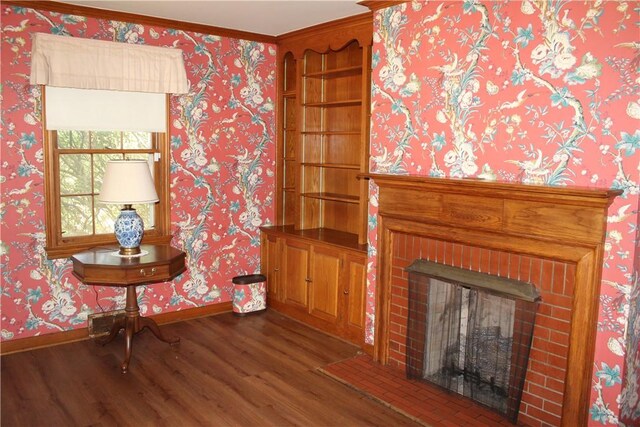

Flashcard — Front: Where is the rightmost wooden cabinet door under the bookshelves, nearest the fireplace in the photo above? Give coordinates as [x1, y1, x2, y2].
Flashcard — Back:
[341, 254, 367, 342]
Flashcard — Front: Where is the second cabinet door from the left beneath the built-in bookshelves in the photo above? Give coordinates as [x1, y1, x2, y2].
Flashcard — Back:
[282, 239, 310, 309]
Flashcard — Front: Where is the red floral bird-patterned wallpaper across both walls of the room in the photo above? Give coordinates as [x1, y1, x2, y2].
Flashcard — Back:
[0, 0, 640, 425]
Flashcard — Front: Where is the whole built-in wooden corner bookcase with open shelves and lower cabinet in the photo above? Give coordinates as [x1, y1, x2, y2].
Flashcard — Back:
[262, 13, 373, 352]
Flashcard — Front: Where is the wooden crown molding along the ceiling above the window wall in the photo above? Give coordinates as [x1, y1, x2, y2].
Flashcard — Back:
[2, 0, 276, 44]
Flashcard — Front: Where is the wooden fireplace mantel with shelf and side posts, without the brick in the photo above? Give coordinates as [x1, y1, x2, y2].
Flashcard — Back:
[361, 174, 621, 426]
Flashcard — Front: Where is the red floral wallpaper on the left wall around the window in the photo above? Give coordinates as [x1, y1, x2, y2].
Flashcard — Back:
[0, 5, 276, 341]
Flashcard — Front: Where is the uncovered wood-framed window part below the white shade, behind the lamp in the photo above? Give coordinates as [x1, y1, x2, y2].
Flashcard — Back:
[45, 130, 171, 258]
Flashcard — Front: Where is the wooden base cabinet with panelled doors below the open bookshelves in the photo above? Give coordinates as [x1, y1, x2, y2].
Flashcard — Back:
[262, 226, 366, 346]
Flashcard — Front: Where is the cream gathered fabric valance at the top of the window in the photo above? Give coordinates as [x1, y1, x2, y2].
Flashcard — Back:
[30, 33, 189, 93]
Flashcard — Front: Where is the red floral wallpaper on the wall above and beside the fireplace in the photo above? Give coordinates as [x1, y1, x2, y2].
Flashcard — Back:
[366, 0, 640, 425]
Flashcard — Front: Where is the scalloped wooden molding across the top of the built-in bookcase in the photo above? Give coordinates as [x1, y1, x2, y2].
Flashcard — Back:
[277, 12, 373, 59]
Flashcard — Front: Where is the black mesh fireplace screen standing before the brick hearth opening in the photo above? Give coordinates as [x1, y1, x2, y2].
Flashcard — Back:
[407, 260, 540, 422]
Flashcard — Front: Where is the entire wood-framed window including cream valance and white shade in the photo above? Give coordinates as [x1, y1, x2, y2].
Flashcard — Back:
[29, 33, 189, 258]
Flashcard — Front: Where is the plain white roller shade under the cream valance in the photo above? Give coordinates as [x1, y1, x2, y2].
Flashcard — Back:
[44, 86, 167, 132]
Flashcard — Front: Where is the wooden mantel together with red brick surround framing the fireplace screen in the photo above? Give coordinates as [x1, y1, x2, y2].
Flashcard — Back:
[368, 175, 620, 426]
